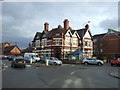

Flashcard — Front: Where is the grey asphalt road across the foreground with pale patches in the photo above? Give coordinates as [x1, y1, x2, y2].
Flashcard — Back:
[2, 61, 119, 88]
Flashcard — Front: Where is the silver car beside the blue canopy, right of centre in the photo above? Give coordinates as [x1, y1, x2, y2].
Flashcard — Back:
[82, 58, 104, 66]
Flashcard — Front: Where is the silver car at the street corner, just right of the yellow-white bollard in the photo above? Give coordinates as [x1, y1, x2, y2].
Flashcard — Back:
[45, 57, 62, 65]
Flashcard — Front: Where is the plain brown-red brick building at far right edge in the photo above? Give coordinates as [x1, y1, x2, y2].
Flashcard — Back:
[93, 29, 120, 58]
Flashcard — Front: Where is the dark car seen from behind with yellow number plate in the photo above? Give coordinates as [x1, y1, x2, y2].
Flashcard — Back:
[11, 58, 26, 68]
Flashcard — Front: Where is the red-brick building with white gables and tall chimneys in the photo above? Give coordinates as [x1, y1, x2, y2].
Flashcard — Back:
[32, 19, 93, 59]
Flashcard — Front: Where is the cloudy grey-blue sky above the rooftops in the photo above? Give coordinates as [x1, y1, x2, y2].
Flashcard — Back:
[0, 2, 118, 49]
